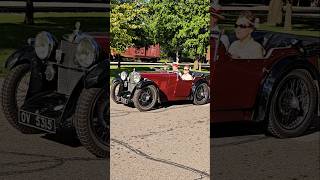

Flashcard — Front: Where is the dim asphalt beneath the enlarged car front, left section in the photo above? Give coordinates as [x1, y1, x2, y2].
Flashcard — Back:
[0, 82, 109, 180]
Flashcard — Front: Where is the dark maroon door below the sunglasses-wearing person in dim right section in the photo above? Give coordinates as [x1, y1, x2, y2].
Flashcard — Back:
[212, 55, 265, 111]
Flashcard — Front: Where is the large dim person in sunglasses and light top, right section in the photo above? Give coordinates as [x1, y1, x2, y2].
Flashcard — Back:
[228, 11, 264, 59]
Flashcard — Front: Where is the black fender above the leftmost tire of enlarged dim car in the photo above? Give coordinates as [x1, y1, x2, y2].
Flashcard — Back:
[5, 45, 36, 69]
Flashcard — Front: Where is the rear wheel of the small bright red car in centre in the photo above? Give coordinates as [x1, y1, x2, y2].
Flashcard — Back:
[193, 83, 210, 105]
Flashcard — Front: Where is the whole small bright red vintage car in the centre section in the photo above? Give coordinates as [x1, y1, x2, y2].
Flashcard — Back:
[111, 71, 210, 111]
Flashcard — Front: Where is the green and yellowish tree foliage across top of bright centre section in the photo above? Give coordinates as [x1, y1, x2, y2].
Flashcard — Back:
[111, 0, 209, 58]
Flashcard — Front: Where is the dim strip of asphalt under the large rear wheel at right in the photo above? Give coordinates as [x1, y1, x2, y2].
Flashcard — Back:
[210, 119, 320, 180]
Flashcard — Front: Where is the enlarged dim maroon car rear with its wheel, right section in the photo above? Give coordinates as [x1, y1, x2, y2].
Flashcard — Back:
[210, 31, 320, 138]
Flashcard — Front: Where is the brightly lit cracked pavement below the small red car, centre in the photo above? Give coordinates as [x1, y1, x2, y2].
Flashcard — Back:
[110, 101, 210, 180]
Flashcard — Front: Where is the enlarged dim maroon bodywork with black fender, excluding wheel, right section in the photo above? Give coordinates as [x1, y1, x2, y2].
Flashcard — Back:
[210, 32, 320, 122]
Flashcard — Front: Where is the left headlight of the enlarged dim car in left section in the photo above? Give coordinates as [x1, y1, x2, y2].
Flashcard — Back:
[34, 31, 57, 60]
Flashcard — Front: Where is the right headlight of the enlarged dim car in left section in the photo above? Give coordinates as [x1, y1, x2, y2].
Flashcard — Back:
[76, 37, 99, 68]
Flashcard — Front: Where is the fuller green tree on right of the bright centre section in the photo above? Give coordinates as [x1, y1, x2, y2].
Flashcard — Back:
[146, 0, 209, 60]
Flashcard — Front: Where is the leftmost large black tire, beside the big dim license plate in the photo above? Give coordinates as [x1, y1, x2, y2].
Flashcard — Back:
[1, 64, 39, 134]
